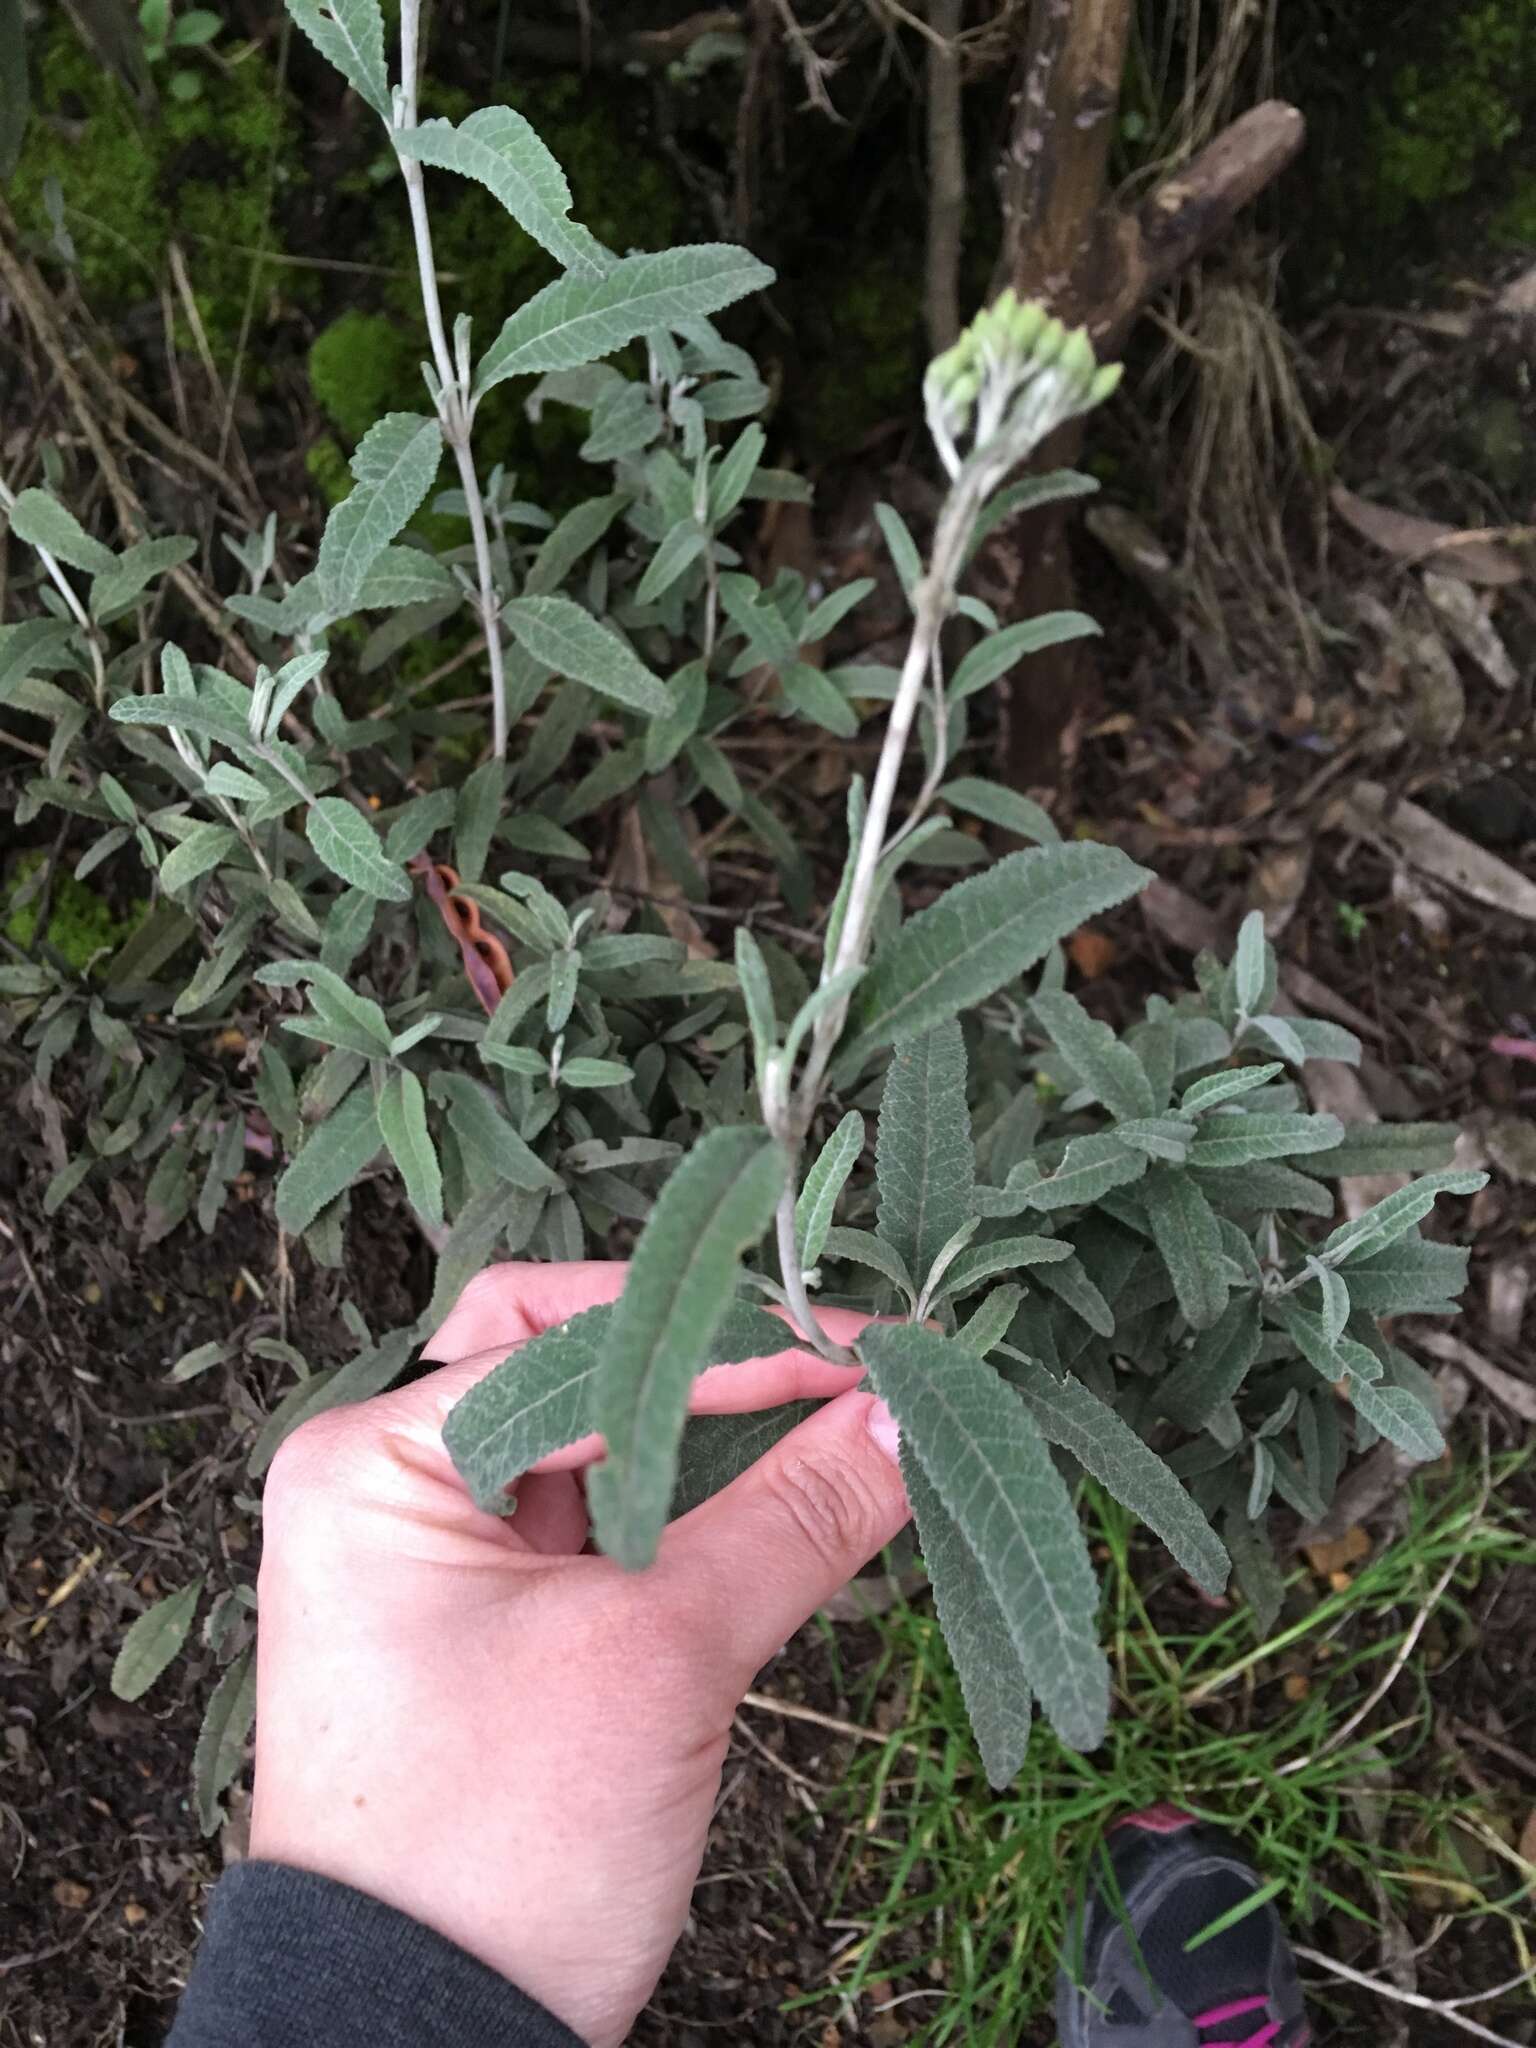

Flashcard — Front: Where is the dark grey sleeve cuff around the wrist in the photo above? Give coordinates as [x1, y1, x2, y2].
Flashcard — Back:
[166, 1864, 584, 2048]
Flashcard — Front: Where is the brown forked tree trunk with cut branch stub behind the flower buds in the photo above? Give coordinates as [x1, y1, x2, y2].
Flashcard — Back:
[993, 0, 1303, 788]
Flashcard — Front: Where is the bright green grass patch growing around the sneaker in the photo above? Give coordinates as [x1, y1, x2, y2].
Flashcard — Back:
[793, 1460, 1536, 2048]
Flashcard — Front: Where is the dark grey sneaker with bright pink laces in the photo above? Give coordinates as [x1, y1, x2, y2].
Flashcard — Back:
[1057, 1806, 1313, 2048]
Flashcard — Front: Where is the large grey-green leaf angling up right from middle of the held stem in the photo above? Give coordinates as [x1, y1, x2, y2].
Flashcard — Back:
[846, 842, 1151, 1065]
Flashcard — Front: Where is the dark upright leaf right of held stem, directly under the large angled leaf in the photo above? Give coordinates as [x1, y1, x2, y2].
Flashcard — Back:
[874, 1022, 975, 1278]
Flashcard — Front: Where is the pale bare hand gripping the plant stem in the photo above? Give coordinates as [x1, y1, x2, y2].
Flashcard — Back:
[250, 1264, 907, 2048]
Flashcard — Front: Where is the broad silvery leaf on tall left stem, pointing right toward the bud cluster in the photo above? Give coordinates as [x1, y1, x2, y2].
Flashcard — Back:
[475, 242, 774, 397]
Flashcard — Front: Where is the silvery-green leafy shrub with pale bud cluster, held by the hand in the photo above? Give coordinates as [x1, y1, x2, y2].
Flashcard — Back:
[0, 0, 1481, 1821]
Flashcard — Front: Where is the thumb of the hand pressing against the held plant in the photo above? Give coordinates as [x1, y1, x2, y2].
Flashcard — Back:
[662, 1391, 911, 1688]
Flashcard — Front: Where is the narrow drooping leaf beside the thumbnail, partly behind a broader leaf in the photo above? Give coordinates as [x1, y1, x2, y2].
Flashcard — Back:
[901, 1442, 1032, 1790]
